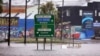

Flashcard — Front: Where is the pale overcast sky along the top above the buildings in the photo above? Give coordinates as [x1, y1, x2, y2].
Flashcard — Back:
[3, 0, 100, 6]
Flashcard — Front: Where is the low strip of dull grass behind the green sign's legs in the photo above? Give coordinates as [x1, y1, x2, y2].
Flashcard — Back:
[10, 37, 65, 43]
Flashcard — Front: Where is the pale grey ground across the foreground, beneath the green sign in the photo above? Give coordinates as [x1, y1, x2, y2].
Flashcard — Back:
[0, 43, 100, 56]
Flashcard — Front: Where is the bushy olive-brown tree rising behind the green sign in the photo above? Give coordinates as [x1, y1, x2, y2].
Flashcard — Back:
[39, 1, 60, 23]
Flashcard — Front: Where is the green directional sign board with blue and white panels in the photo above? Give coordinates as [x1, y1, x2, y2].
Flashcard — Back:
[34, 14, 54, 38]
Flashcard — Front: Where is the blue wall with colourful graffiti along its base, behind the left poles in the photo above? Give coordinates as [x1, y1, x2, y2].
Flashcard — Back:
[0, 19, 34, 38]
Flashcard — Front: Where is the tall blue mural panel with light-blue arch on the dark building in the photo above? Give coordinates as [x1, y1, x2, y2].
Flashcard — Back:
[80, 11, 94, 39]
